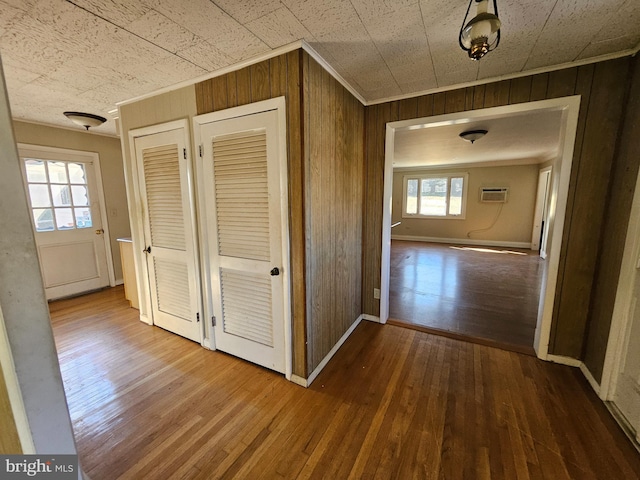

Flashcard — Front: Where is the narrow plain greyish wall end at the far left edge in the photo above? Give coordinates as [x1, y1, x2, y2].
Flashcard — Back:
[0, 58, 76, 454]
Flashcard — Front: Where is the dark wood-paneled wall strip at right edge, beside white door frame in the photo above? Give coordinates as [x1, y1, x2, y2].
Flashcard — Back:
[584, 56, 640, 382]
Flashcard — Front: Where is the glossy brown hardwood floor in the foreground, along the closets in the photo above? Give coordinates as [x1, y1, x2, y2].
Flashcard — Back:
[50, 287, 640, 480]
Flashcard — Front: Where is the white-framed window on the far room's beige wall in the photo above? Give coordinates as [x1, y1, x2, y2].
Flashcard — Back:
[402, 173, 469, 218]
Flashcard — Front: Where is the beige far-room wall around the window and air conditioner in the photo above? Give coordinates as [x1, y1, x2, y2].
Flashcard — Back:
[391, 165, 540, 246]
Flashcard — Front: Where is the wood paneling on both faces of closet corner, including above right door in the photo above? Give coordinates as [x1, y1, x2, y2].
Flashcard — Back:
[195, 50, 364, 378]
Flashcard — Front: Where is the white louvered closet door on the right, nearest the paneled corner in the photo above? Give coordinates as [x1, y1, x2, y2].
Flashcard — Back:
[200, 111, 285, 372]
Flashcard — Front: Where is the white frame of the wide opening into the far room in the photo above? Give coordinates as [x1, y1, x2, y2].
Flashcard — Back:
[380, 96, 580, 359]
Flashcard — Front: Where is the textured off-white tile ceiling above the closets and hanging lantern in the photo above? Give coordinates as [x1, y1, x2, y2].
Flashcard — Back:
[0, 0, 640, 134]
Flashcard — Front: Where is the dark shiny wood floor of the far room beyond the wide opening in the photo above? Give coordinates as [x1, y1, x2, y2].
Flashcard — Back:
[389, 240, 545, 354]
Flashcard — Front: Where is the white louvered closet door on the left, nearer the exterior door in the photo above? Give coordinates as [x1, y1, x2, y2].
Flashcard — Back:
[135, 129, 201, 342]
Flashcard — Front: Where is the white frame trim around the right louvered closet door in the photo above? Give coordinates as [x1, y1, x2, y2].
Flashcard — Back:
[193, 96, 293, 380]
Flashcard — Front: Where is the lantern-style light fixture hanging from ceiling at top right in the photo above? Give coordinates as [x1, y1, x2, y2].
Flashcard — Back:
[458, 0, 500, 60]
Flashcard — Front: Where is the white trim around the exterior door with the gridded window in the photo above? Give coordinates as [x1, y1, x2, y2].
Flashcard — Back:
[16, 143, 116, 287]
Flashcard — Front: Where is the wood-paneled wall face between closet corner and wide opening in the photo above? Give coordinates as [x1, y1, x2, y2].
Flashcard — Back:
[302, 52, 364, 372]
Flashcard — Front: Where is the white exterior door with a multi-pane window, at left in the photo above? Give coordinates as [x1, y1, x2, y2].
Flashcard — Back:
[19, 146, 110, 300]
